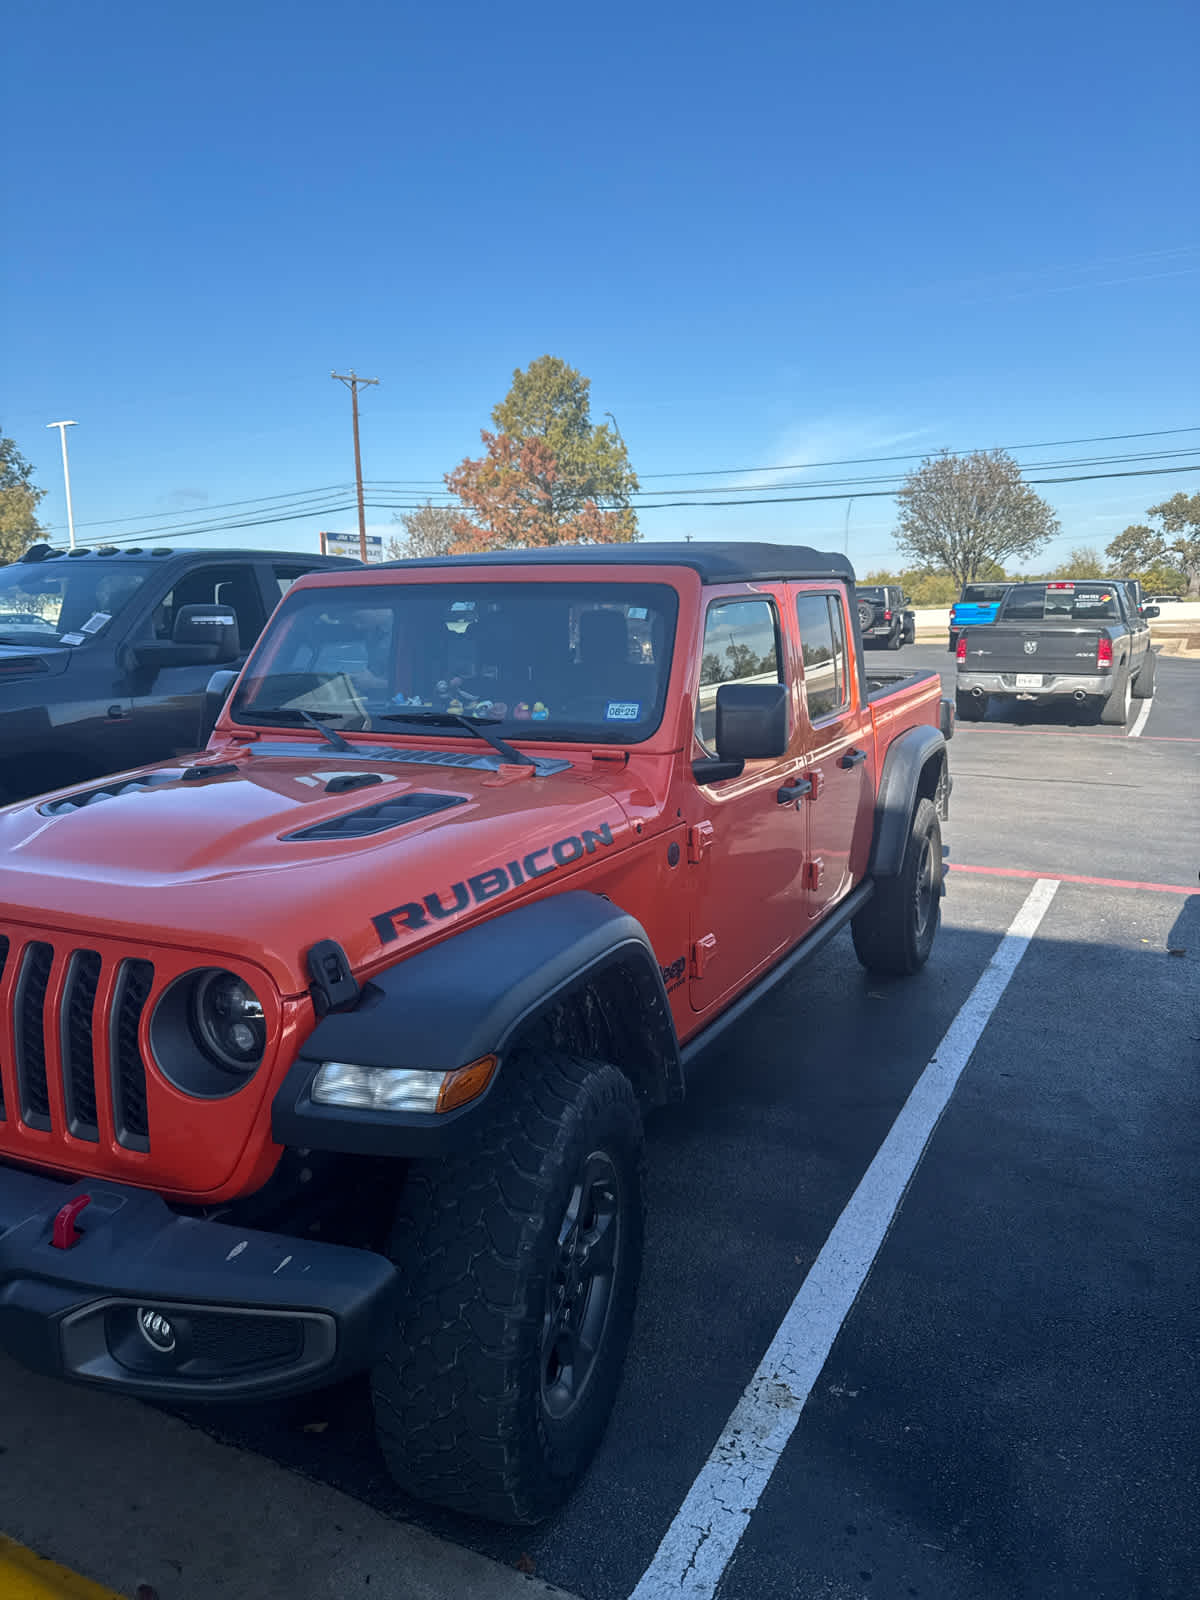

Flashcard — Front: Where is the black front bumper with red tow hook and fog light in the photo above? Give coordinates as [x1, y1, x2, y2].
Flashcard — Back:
[0, 1165, 397, 1400]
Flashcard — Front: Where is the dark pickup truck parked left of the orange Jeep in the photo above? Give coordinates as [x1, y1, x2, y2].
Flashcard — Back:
[0, 544, 360, 805]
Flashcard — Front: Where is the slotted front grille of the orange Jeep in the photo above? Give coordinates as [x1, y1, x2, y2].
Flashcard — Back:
[0, 934, 154, 1155]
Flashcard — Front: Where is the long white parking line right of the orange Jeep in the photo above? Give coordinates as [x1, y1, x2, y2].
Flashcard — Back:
[632, 878, 1058, 1600]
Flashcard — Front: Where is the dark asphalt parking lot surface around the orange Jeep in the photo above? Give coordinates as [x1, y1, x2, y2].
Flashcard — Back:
[0, 645, 1200, 1600]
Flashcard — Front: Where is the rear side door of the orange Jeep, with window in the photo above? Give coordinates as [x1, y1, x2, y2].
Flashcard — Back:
[792, 586, 874, 922]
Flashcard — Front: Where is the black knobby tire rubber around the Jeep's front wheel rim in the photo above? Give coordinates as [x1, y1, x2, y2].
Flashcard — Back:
[373, 1050, 645, 1523]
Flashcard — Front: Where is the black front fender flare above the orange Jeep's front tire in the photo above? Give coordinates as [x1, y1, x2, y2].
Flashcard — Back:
[272, 890, 683, 1155]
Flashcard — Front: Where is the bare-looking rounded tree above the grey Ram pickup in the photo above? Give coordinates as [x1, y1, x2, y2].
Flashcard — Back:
[894, 450, 1059, 584]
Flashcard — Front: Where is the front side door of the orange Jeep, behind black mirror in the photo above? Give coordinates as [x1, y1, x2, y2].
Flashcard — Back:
[688, 584, 808, 1011]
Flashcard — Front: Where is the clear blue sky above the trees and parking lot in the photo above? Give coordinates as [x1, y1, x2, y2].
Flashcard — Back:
[0, 0, 1200, 570]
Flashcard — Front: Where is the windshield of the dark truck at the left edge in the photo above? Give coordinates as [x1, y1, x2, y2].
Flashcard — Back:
[0, 557, 150, 645]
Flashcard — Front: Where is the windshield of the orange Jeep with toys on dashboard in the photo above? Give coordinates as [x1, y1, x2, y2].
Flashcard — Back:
[230, 582, 677, 744]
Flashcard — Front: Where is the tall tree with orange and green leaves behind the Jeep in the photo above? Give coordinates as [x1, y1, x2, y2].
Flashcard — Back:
[446, 355, 638, 552]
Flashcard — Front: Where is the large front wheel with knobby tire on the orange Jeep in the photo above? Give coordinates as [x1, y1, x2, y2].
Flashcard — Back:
[371, 1050, 643, 1523]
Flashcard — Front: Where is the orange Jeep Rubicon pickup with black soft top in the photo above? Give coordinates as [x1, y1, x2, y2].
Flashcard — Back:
[0, 542, 952, 1523]
